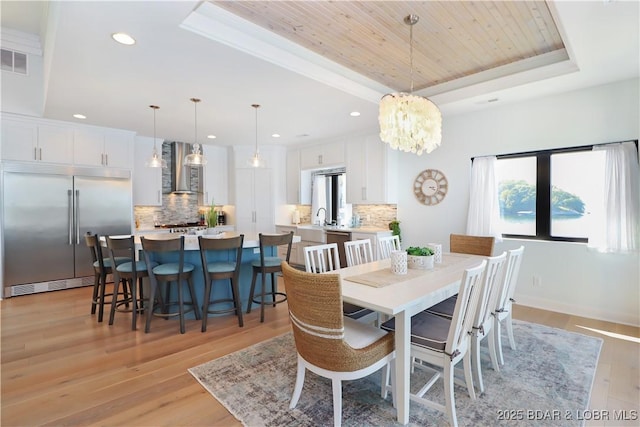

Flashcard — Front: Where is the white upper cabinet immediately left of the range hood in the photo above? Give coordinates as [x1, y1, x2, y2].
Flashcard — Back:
[133, 136, 162, 206]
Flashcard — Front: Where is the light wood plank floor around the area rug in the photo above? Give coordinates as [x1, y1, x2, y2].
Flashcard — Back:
[0, 282, 640, 426]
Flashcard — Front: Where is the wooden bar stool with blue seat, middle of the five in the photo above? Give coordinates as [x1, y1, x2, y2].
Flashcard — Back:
[140, 236, 200, 334]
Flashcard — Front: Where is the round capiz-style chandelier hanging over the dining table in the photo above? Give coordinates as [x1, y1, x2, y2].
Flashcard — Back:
[378, 15, 442, 155]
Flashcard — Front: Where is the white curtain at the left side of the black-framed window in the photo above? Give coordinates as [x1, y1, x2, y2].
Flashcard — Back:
[467, 156, 502, 241]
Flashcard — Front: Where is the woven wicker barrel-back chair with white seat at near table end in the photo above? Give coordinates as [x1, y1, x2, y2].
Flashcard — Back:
[282, 262, 395, 426]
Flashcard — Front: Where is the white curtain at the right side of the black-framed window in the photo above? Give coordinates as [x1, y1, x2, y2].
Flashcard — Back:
[589, 142, 640, 252]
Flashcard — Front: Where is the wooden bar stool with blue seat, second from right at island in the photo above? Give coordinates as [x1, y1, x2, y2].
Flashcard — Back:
[198, 234, 244, 332]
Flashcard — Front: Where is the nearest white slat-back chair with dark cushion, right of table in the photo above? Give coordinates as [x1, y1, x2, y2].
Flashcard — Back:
[382, 260, 487, 426]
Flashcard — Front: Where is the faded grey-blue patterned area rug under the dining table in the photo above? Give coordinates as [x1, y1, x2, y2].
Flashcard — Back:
[189, 321, 602, 427]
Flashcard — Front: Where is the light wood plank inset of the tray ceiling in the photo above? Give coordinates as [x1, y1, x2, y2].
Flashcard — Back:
[212, 1, 565, 91]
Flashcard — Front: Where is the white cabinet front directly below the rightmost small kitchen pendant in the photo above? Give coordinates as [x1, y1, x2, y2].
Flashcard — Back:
[235, 168, 275, 233]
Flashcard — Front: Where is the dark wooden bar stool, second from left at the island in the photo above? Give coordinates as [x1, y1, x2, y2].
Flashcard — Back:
[106, 236, 156, 331]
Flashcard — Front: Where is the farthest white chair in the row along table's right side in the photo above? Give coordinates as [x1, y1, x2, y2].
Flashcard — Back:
[493, 246, 524, 365]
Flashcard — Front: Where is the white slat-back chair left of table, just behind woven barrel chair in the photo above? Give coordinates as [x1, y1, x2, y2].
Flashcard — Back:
[304, 240, 375, 322]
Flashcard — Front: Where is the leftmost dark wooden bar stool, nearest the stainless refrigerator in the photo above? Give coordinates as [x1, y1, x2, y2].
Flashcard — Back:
[84, 233, 129, 322]
